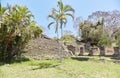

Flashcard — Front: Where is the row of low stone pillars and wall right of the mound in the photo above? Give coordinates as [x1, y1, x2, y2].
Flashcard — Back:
[79, 47, 120, 57]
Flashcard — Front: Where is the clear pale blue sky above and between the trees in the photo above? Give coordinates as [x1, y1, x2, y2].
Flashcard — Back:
[0, 0, 120, 37]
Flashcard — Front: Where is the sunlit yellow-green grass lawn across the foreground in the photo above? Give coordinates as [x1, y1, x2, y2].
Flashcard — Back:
[0, 58, 120, 78]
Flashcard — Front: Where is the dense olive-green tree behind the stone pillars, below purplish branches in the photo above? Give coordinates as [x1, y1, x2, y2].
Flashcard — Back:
[79, 19, 112, 55]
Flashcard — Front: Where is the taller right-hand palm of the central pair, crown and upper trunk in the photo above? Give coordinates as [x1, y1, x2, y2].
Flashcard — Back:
[56, 0, 75, 37]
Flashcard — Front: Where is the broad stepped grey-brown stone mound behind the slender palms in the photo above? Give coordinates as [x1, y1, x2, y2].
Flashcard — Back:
[24, 35, 70, 60]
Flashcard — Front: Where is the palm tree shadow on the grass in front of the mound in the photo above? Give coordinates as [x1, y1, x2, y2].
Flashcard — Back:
[32, 62, 59, 70]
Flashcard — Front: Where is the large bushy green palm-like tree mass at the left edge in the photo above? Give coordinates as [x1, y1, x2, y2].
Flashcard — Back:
[0, 5, 42, 63]
